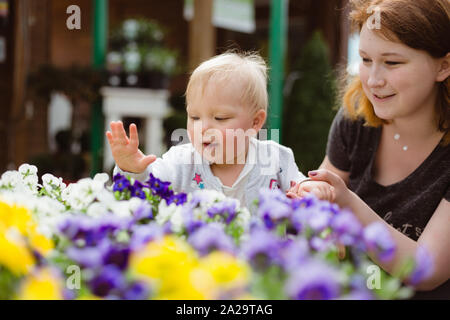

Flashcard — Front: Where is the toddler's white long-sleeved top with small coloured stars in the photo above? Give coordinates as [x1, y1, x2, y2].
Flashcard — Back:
[114, 138, 306, 212]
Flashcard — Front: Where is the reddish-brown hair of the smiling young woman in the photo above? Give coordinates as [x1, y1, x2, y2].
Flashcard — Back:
[343, 0, 450, 145]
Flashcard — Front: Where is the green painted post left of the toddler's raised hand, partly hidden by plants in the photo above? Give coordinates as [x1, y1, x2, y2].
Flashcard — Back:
[91, 0, 108, 176]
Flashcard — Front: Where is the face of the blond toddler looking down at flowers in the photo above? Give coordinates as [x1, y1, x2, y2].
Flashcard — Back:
[187, 84, 256, 164]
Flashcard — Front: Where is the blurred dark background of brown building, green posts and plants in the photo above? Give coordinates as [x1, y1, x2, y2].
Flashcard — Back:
[0, 0, 357, 182]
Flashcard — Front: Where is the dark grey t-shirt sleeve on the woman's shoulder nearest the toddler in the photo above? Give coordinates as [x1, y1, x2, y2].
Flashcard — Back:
[327, 108, 352, 171]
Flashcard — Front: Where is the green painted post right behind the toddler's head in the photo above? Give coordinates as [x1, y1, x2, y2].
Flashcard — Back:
[267, 0, 289, 142]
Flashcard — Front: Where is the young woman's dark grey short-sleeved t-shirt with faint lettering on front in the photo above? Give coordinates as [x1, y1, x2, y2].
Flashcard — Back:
[327, 109, 450, 299]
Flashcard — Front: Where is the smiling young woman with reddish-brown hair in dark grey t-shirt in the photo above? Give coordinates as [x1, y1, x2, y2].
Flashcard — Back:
[310, 0, 450, 299]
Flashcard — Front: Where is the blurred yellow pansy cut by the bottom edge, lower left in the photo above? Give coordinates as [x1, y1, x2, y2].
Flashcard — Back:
[17, 269, 63, 300]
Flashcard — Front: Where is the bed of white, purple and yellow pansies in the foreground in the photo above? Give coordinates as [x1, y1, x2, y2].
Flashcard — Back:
[0, 164, 430, 299]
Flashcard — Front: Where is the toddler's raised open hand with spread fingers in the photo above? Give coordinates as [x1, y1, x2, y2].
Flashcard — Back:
[106, 121, 156, 173]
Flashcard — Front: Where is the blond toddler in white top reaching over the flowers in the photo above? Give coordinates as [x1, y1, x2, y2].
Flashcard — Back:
[106, 52, 334, 212]
